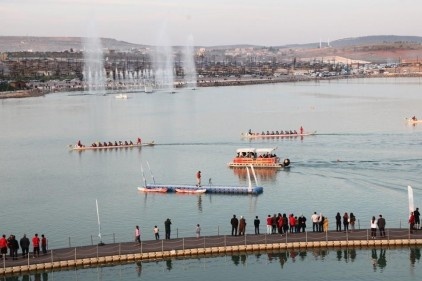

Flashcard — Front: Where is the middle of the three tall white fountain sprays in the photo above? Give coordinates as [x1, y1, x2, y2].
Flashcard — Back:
[154, 23, 174, 93]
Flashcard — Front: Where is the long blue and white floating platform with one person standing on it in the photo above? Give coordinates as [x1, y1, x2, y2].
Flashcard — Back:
[138, 184, 264, 195]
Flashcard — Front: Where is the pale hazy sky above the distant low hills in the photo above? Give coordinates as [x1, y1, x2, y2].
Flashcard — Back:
[0, 0, 422, 46]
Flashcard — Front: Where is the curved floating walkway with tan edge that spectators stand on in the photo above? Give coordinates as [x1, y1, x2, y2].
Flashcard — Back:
[0, 229, 422, 275]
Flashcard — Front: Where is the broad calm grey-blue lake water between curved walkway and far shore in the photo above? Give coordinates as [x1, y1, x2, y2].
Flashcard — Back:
[0, 78, 422, 278]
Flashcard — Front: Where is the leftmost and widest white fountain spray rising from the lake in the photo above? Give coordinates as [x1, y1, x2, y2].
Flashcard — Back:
[83, 22, 106, 95]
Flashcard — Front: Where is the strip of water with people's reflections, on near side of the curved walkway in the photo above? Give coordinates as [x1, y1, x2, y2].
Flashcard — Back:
[4, 248, 422, 281]
